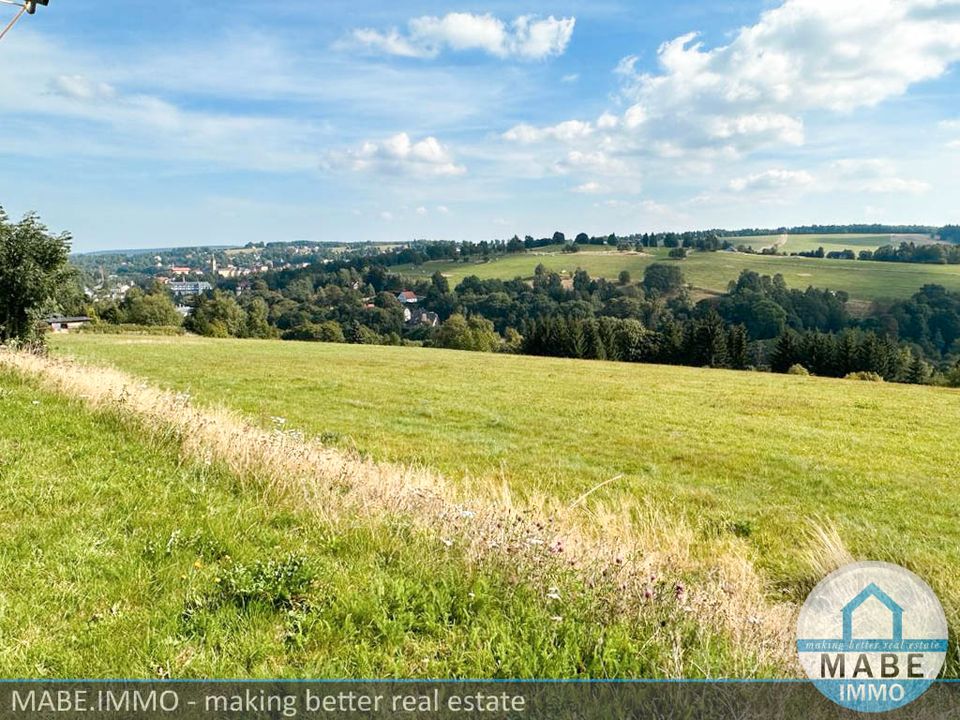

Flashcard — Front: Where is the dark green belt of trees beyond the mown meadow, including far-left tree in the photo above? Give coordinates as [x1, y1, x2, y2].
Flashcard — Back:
[0, 207, 960, 382]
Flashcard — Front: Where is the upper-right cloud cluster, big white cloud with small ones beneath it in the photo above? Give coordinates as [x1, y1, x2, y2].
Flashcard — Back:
[501, 0, 960, 193]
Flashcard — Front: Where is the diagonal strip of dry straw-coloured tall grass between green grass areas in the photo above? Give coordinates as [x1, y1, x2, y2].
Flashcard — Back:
[0, 349, 808, 677]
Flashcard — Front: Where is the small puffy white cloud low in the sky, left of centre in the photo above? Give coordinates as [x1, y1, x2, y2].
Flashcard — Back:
[326, 133, 467, 177]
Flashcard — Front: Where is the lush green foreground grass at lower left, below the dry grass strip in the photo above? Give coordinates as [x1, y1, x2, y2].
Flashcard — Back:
[0, 371, 752, 677]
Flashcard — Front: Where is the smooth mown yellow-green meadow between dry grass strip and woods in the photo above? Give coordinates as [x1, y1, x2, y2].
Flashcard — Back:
[57, 336, 960, 607]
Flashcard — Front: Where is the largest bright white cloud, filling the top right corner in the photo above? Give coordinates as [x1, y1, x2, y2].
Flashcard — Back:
[628, 0, 960, 114]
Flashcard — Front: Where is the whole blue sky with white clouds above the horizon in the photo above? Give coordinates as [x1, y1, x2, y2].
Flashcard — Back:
[0, 0, 960, 252]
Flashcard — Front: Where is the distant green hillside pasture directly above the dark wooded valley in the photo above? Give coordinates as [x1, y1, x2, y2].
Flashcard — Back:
[394, 248, 960, 301]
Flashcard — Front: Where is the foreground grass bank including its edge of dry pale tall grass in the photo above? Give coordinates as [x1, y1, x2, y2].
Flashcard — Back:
[0, 353, 768, 679]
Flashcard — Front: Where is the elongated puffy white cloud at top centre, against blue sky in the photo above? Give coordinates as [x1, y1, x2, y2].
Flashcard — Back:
[352, 13, 576, 60]
